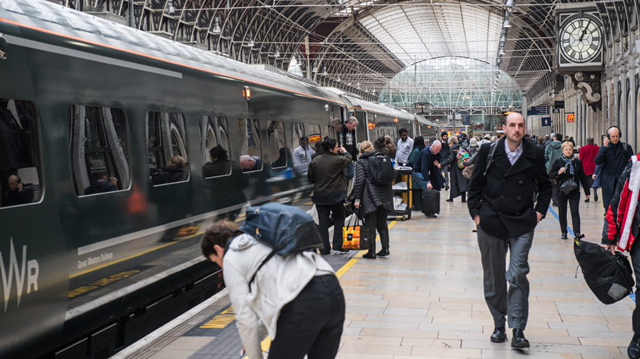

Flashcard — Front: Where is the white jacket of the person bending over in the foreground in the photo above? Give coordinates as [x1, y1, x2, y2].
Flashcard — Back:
[222, 234, 335, 359]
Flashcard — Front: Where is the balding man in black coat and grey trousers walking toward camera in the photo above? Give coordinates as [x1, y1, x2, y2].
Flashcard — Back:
[468, 113, 552, 349]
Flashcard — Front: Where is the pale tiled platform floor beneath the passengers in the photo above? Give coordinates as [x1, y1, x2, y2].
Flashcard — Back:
[120, 192, 635, 359]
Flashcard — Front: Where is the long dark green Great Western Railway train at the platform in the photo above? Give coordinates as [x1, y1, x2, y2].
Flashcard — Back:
[0, 0, 417, 359]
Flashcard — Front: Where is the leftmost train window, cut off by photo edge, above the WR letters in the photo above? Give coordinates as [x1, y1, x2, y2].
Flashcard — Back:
[0, 99, 42, 207]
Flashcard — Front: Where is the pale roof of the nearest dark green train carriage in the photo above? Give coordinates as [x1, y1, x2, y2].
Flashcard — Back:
[0, 0, 343, 104]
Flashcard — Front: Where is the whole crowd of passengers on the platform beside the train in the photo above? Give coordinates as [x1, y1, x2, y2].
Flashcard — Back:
[201, 114, 640, 359]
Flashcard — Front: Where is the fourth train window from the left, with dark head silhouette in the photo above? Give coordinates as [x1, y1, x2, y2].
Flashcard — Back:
[200, 116, 231, 178]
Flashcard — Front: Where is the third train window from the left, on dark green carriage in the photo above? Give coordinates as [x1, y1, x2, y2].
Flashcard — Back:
[146, 111, 189, 186]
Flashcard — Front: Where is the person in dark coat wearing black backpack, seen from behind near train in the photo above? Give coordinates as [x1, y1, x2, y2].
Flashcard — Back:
[353, 141, 393, 259]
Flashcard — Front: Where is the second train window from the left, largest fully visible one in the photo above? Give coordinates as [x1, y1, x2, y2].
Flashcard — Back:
[69, 105, 131, 196]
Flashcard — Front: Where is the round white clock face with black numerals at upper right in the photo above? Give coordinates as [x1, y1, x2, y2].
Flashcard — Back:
[559, 17, 602, 63]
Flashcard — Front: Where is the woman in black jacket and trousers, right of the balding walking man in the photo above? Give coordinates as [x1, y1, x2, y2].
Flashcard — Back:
[549, 141, 590, 239]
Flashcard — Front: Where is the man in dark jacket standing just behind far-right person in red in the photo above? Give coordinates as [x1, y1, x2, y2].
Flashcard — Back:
[595, 126, 634, 212]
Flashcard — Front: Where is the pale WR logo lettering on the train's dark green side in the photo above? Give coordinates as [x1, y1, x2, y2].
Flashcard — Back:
[0, 238, 40, 313]
